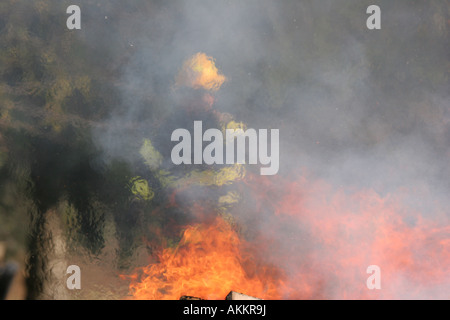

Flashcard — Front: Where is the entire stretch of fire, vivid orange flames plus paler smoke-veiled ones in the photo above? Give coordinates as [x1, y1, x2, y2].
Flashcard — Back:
[123, 174, 450, 299]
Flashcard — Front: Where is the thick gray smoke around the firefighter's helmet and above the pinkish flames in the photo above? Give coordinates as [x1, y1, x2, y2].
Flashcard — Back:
[93, 1, 449, 192]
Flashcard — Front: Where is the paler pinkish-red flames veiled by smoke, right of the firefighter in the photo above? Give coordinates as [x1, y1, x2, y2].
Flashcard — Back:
[248, 176, 450, 299]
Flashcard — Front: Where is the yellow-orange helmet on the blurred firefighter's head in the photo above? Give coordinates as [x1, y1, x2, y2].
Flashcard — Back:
[176, 52, 226, 91]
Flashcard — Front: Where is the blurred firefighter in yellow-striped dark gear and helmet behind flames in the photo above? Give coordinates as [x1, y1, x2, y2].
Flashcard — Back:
[130, 53, 250, 231]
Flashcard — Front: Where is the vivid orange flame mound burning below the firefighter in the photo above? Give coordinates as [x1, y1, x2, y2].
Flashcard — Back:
[123, 217, 280, 300]
